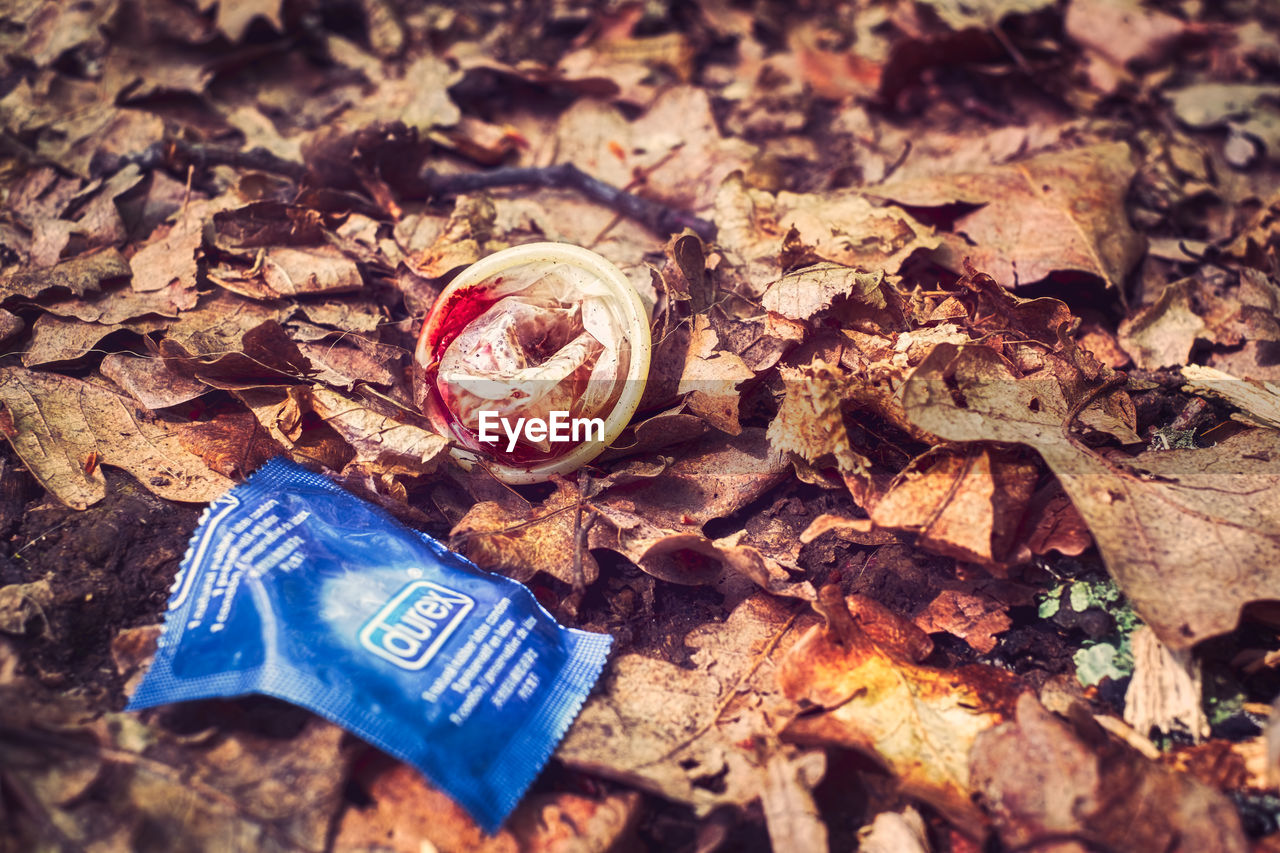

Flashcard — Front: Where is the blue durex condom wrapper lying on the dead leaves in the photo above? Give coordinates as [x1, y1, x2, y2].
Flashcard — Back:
[128, 459, 613, 833]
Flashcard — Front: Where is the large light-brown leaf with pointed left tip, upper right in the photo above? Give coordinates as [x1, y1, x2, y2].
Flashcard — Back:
[874, 142, 1146, 289]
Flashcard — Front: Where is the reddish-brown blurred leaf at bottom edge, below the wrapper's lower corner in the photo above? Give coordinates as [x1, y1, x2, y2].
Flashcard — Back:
[333, 763, 640, 853]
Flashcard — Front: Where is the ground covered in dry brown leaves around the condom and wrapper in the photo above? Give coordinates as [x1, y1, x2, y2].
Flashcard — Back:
[0, 0, 1280, 852]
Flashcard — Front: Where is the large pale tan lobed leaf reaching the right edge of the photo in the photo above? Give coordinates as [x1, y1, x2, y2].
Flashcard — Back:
[904, 345, 1280, 649]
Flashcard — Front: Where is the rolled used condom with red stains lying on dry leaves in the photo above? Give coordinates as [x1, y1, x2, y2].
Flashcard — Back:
[415, 243, 650, 483]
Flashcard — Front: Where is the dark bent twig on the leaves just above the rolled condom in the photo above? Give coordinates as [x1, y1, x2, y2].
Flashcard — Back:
[421, 163, 716, 241]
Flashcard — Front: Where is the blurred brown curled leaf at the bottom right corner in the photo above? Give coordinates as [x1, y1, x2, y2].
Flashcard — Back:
[973, 693, 1249, 853]
